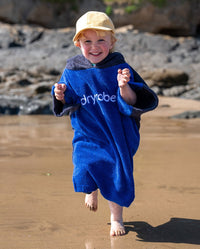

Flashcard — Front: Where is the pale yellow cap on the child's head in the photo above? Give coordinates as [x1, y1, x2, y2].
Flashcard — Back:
[73, 11, 115, 41]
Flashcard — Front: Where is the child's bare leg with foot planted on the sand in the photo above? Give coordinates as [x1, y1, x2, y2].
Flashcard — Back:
[108, 201, 125, 236]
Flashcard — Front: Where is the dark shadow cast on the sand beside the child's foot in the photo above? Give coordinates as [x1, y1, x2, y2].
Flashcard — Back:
[124, 218, 200, 245]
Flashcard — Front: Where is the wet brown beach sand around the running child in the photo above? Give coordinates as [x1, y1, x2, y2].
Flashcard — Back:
[0, 98, 200, 249]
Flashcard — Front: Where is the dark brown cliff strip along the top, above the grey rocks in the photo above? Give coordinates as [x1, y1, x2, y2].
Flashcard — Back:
[0, 0, 200, 36]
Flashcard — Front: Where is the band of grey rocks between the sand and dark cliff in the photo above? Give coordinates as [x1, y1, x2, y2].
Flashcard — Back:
[0, 24, 200, 114]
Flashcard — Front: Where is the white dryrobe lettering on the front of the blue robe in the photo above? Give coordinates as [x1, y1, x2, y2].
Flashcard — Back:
[81, 92, 116, 105]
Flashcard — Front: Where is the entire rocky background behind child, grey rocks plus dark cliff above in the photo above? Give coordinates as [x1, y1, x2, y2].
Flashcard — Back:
[0, 0, 200, 114]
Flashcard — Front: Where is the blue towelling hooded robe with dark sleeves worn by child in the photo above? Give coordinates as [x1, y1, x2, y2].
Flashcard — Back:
[52, 53, 158, 207]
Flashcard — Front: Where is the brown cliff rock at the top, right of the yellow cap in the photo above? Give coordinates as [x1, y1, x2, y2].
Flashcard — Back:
[112, 0, 200, 36]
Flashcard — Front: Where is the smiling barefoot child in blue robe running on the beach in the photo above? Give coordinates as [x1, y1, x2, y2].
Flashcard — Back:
[52, 11, 158, 236]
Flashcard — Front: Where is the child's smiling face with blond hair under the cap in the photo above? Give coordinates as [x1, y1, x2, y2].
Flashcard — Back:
[76, 29, 114, 64]
